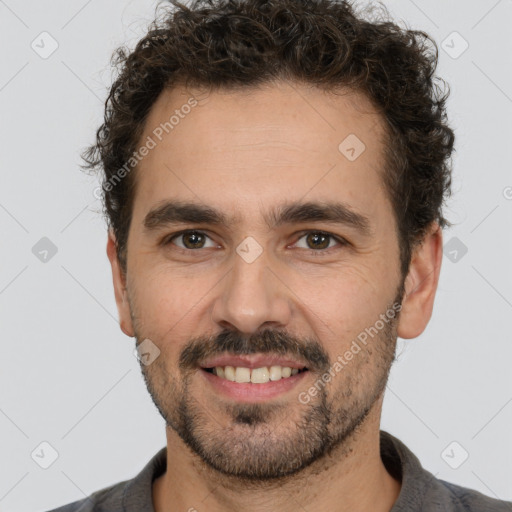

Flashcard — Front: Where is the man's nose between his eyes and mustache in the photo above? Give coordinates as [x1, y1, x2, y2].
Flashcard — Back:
[212, 245, 291, 334]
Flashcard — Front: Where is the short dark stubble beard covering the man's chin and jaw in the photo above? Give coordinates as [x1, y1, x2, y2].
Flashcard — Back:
[132, 295, 401, 486]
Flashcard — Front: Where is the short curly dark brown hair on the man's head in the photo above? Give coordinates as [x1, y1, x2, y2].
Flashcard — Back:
[82, 0, 454, 277]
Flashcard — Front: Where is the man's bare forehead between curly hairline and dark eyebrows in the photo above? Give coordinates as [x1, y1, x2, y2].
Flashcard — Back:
[133, 83, 390, 232]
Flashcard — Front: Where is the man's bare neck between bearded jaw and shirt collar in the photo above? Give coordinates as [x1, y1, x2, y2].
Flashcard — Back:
[153, 398, 401, 512]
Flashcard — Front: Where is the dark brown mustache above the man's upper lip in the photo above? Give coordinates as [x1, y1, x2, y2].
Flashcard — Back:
[179, 329, 330, 372]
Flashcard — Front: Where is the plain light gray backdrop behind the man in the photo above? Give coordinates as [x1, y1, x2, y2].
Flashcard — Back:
[0, 0, 512, 512]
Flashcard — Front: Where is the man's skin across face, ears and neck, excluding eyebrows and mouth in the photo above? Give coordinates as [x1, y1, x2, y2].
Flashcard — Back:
[107, 82, 442, 512]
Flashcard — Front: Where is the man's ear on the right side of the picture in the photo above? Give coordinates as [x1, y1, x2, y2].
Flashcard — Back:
[397, 222, 443, 339]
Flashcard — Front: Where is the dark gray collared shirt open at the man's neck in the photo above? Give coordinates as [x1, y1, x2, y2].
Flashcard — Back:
[48, 430, 512, 512]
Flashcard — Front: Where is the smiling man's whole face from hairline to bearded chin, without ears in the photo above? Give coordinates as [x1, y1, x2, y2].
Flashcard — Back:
[112, 84, 403, 479]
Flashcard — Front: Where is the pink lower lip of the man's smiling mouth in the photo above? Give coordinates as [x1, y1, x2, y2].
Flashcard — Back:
[200, 369, 309, 402]
